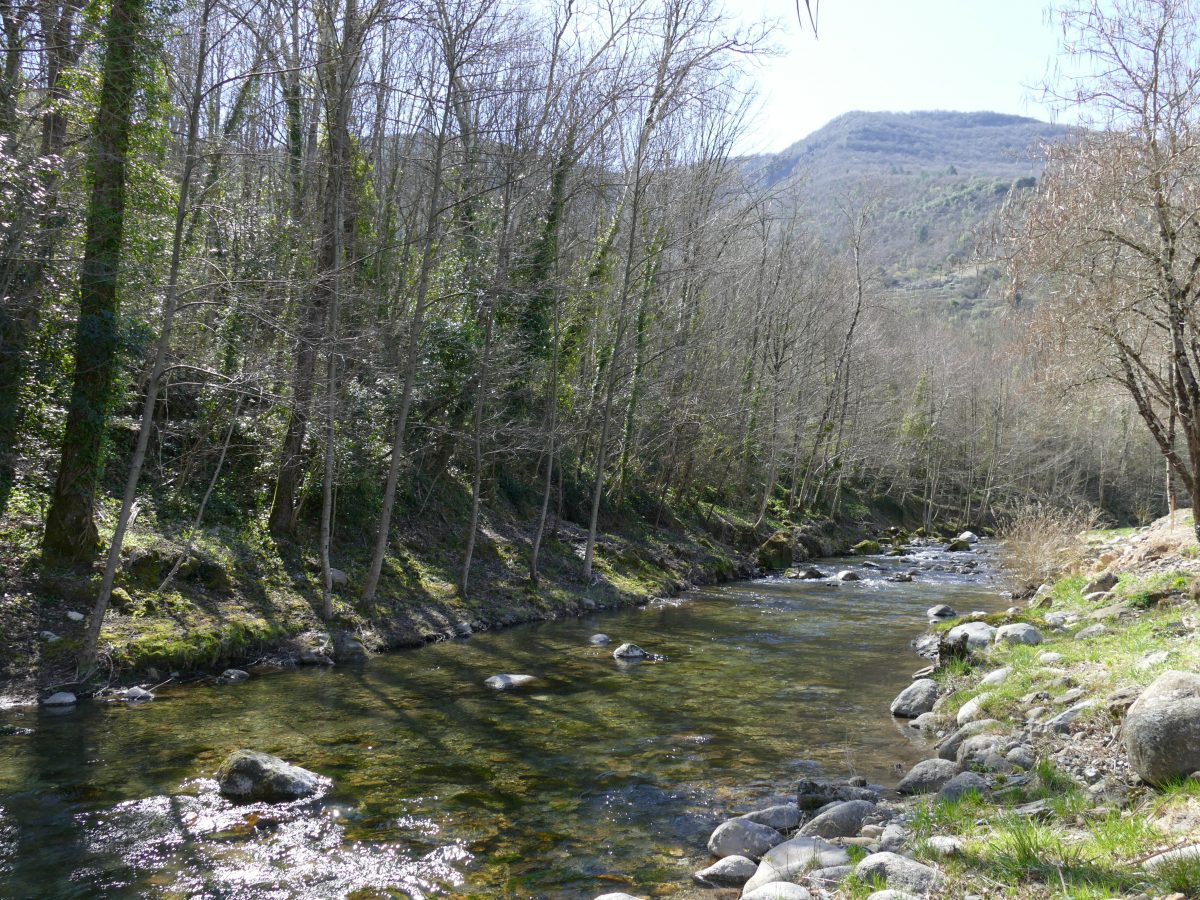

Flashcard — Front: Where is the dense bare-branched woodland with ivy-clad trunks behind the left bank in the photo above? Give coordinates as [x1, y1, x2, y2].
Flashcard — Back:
[0, 0, 1169, 668]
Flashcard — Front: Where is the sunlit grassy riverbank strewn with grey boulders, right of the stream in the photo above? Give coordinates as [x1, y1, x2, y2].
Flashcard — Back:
[602, 517, 1200, 900]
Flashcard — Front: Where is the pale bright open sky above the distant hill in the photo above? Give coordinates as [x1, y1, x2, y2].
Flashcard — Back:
[730, 0, 1062, 152]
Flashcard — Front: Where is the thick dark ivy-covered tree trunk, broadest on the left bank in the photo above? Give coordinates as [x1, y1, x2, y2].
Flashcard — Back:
[42, 0, 146, 571]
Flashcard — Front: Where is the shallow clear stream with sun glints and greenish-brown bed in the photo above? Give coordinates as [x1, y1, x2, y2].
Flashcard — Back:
[0, 553, 1007, 900]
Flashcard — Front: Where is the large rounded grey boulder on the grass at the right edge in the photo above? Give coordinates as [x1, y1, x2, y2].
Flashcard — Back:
[1124, 671, 1200, 785]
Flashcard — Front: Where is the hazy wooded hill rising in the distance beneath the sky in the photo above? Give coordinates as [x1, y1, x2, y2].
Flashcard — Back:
[745, 112, 1072, 313]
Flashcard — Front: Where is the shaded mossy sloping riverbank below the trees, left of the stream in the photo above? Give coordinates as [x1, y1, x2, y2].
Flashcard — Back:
[0, 487, 921, 703]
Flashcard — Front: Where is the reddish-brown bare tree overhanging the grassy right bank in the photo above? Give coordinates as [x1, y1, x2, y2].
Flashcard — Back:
[1018, 0, 1200, 535]
